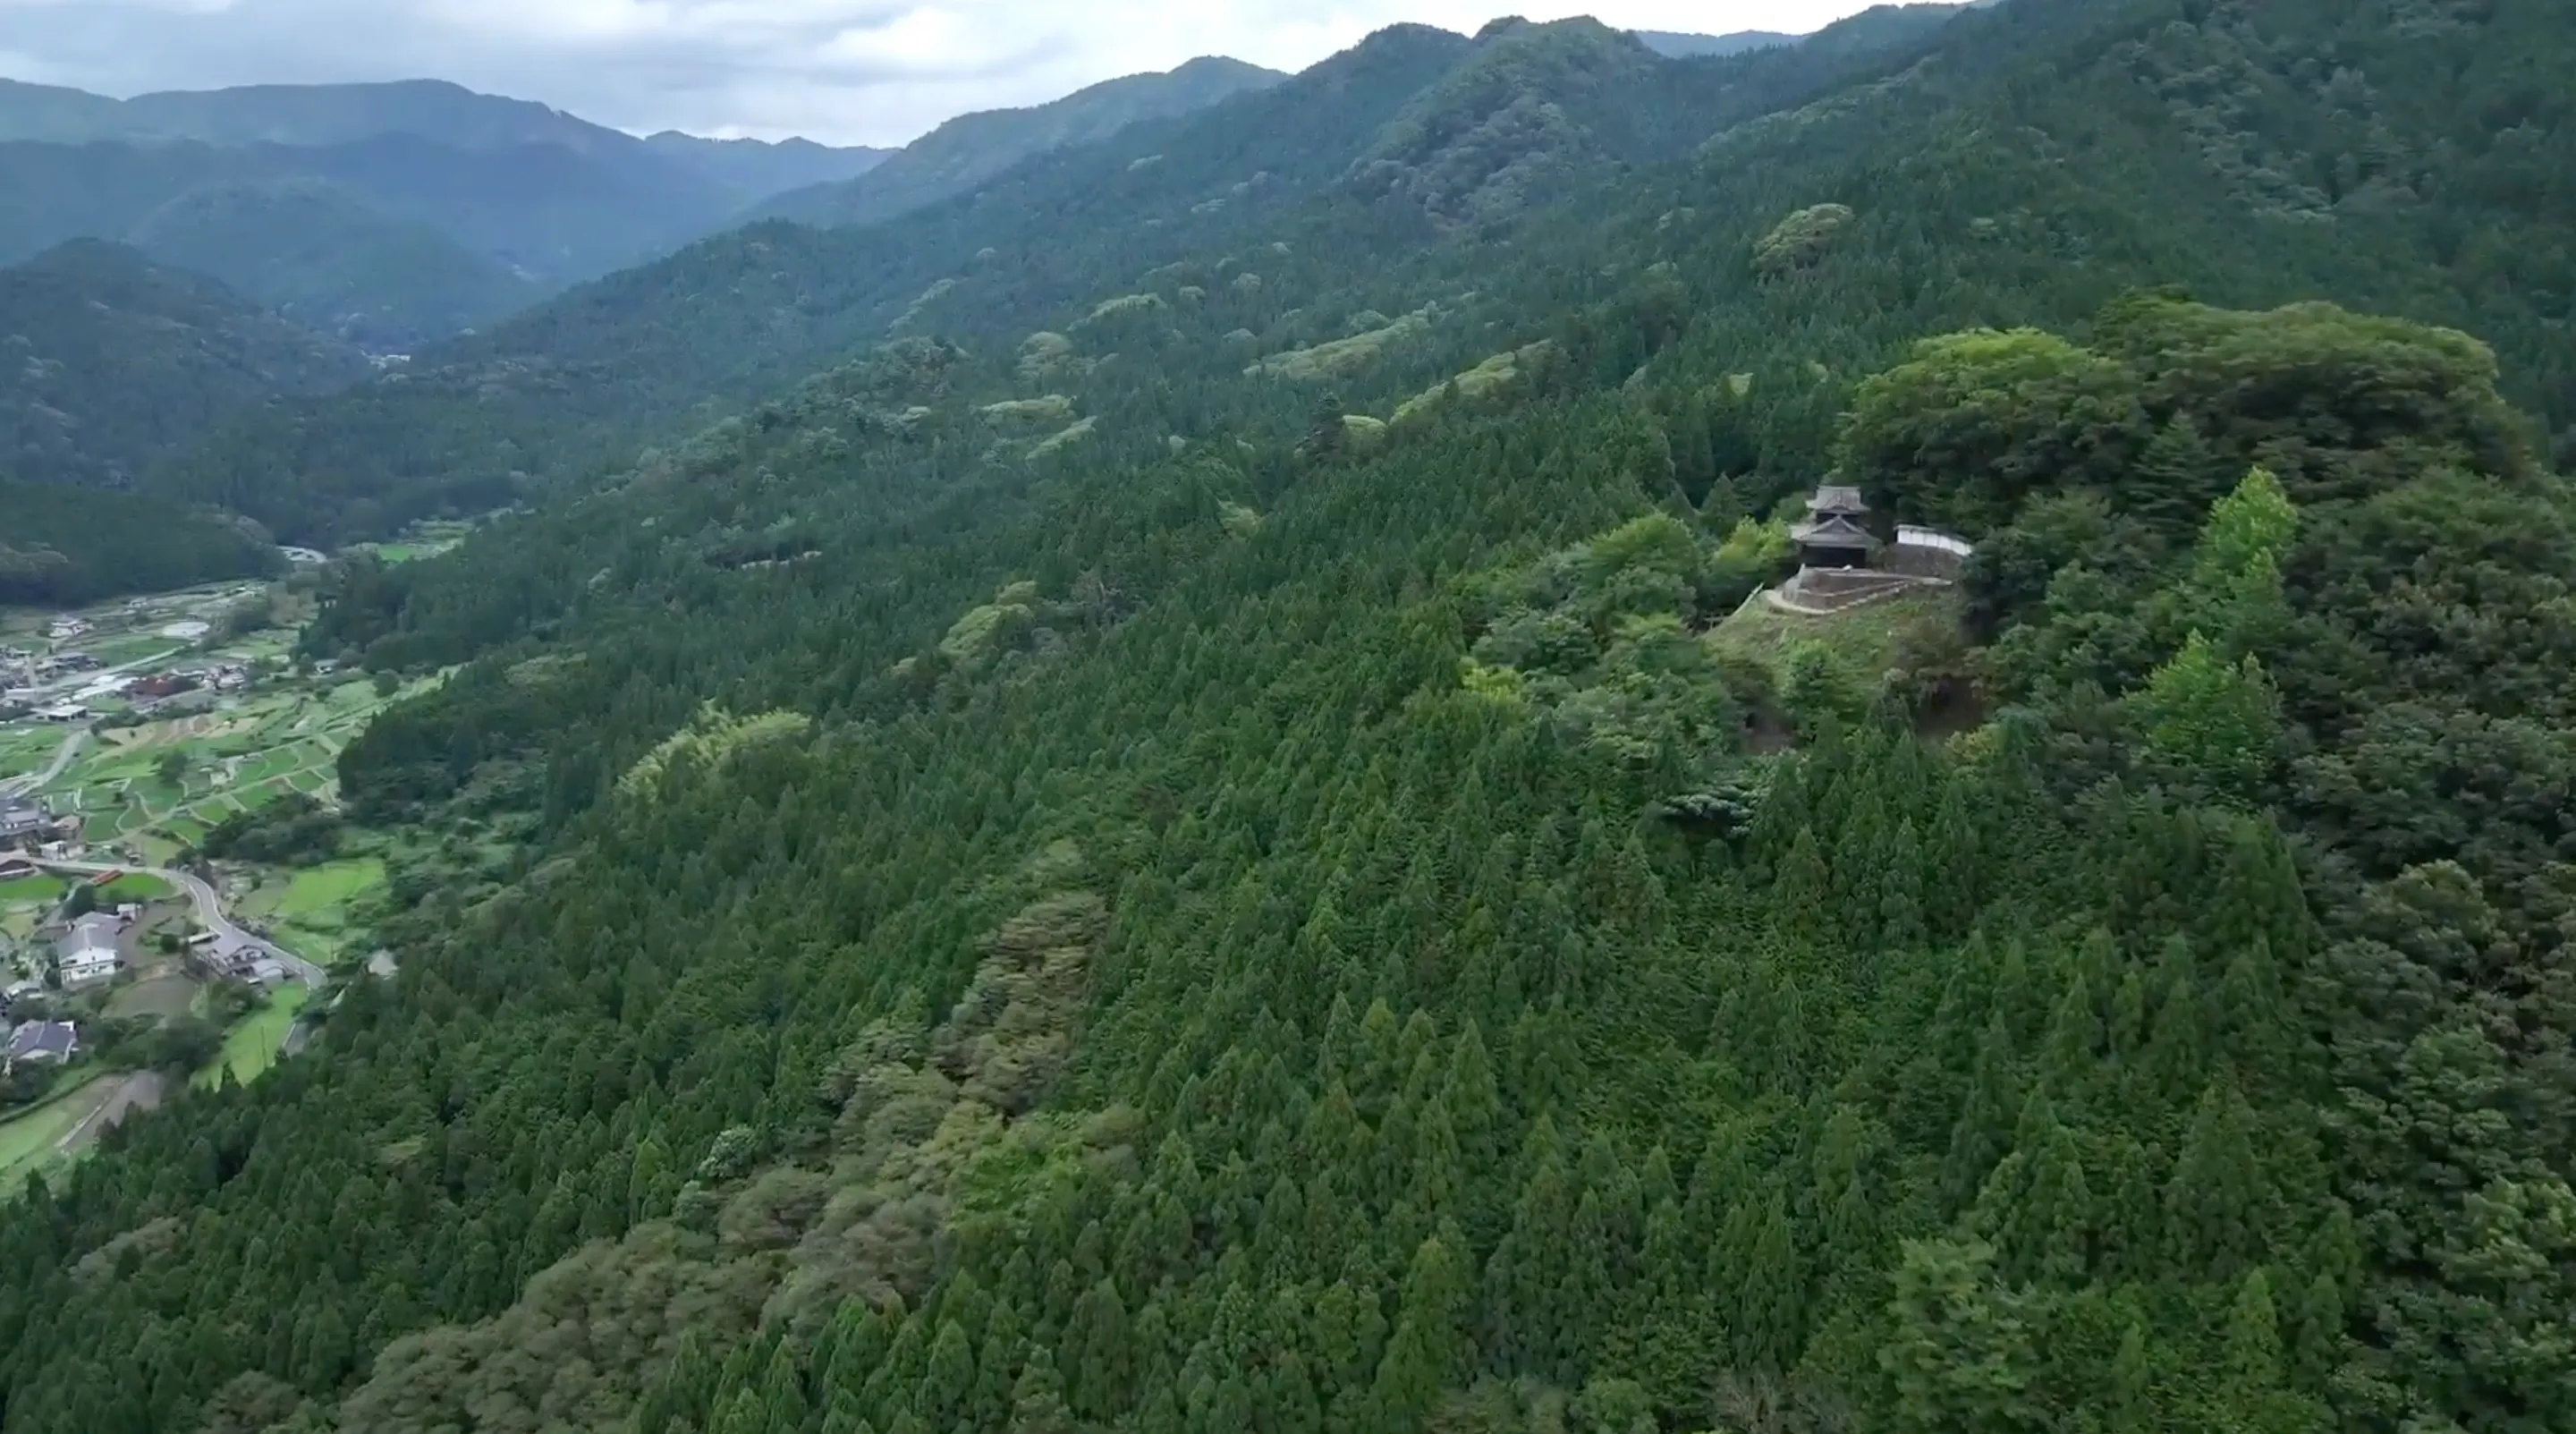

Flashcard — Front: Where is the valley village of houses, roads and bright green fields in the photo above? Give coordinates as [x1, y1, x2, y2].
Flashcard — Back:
[0, 584, 417, 1194]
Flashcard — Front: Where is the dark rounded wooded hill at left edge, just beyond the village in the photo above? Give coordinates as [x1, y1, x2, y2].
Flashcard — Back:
[0, 240, 369, 484]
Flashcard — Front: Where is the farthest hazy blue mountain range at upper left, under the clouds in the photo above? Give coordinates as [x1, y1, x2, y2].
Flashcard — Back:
[0, 80, 876, 350]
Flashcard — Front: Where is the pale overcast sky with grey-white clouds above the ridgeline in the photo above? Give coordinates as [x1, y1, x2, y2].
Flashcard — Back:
[0, 0, 1895, 144]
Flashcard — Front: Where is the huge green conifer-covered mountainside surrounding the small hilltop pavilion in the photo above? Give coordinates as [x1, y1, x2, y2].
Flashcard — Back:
[0, 0, 2576, 1434]
